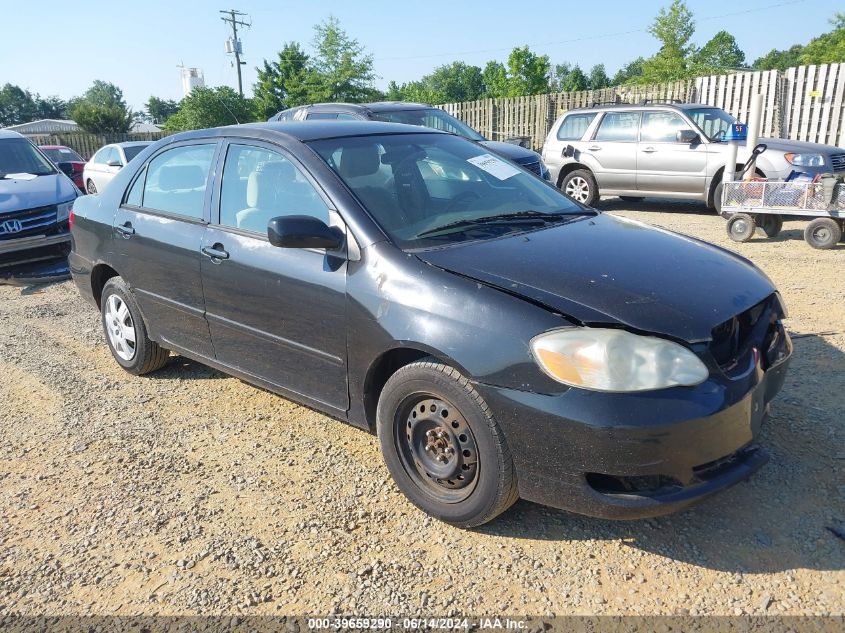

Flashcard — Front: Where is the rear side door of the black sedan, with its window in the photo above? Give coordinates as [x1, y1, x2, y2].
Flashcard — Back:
[114, 140, 219, 358]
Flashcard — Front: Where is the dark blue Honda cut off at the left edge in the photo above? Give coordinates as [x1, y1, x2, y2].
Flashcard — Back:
[0, 130, 80, 284]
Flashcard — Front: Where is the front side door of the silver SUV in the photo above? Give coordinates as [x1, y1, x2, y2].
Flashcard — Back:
[637, 110, 707, 196]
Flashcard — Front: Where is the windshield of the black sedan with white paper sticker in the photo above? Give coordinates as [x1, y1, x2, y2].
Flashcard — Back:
[309, 133, 592, 248]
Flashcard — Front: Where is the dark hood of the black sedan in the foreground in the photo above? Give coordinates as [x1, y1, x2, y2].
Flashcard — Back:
[417, 214, 775, 343]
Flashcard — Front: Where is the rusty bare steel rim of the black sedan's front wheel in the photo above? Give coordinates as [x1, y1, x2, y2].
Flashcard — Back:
[394, 394, 479, 503]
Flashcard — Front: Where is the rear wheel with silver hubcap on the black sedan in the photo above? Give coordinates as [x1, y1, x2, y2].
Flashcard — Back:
[100, 277, 170, 376]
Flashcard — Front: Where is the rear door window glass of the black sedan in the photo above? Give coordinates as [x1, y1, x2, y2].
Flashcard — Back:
[140, 144, 215, 220]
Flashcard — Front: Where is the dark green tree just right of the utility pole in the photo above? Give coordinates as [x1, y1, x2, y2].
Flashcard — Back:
[253, 42, 310, 119]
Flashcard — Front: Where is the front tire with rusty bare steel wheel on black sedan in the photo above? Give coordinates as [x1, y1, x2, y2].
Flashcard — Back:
[376, 359, 519, 528]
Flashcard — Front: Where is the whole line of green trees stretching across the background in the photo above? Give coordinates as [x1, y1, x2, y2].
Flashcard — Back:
[0, 0, 845, 133]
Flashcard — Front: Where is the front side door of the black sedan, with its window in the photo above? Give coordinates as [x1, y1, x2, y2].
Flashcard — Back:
[201, 141, 349, 411]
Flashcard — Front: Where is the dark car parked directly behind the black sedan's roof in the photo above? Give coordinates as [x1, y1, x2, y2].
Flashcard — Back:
[270, 101, 549, 180]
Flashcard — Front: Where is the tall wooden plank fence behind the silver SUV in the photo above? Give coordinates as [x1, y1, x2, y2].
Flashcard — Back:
[440, 63, 845, 150]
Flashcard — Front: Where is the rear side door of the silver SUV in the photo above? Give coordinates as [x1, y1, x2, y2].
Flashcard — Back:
[581, 111, 640, 192]
